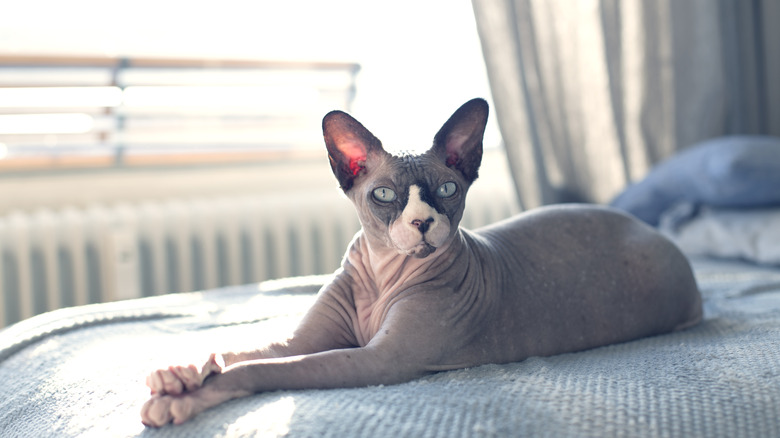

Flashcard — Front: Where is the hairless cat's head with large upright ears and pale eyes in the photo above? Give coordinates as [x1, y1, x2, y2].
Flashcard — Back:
[322, 99, 488, 258]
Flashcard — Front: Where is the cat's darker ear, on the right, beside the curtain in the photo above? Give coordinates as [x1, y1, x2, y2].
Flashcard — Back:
[431, 99, 488, 183]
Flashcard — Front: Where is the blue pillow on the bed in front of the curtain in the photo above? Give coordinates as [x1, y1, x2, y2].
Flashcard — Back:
[611, 136, 780, 226]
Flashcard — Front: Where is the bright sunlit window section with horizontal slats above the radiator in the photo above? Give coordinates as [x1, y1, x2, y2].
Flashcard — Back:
[0, 56, 360, 172]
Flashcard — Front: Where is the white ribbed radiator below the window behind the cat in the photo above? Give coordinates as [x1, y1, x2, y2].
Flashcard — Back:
[0, 192, 513, 327]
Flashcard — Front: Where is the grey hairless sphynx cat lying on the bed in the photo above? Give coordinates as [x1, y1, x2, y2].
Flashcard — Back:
[141, 99, 702, 426]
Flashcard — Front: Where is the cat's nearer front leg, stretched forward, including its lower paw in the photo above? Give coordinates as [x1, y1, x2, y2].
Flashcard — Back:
[141, 296, 458, 426]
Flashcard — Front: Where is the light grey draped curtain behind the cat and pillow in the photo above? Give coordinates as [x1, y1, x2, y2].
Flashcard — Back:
[472, 0, 780, 208]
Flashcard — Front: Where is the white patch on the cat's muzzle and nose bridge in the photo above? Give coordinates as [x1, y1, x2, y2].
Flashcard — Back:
[389, 184, 450, 257]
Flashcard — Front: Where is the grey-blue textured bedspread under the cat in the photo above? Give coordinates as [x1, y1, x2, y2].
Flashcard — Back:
[0, 260, 780, 438]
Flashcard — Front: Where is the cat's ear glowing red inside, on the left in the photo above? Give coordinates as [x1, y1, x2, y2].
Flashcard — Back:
[322, 111, 384, 191]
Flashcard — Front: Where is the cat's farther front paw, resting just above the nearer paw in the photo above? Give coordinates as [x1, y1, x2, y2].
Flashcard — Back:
[146, 354, 225, 395]
